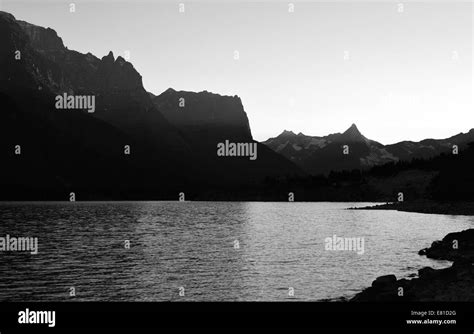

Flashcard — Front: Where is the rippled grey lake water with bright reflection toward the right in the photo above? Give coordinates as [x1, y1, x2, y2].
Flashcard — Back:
[0, 202, 474, 301]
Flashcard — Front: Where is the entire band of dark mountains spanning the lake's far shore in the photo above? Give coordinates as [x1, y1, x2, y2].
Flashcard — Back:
[0, 12, 474, 201]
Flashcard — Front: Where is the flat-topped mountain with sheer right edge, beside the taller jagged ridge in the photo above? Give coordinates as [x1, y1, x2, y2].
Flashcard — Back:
[153, 88, 304, 184]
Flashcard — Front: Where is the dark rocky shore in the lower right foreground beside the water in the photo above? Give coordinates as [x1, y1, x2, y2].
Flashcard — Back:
[349, 229, 474, 302]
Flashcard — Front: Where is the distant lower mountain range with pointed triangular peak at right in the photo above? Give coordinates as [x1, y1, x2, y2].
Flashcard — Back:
[263, 124, 474, 175]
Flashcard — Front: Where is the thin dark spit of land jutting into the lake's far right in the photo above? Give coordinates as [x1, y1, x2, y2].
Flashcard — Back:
[349, 200, 474, 216]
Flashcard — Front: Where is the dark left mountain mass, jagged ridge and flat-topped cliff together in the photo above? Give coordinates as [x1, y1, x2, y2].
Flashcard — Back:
[0, 12, 304, 199]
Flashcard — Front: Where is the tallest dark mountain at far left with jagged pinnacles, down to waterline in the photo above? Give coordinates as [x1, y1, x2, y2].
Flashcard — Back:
[0, 12, 189, 199]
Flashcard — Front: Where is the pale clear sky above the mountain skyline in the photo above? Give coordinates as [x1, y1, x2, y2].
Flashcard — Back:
[2, 0, 474, 144]
